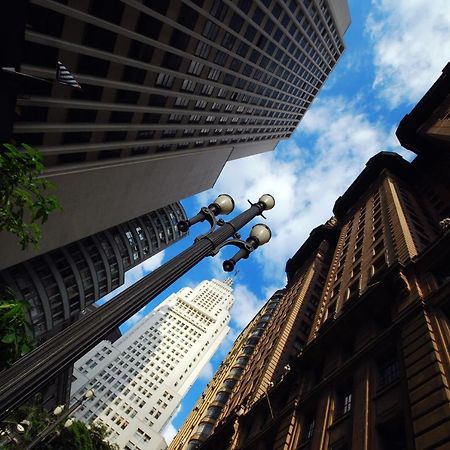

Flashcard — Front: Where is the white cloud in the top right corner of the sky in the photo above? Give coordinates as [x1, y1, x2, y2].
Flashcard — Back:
[366, 0, 450, 107]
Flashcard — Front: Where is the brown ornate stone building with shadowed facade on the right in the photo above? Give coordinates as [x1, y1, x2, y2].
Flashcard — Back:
[173, 66, 450, 450]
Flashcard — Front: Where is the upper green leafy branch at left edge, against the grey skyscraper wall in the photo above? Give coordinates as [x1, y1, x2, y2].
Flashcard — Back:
[0, 144, 61, 250]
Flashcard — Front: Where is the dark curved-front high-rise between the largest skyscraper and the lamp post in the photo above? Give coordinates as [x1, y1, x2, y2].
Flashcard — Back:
[0, 202, 186, 341]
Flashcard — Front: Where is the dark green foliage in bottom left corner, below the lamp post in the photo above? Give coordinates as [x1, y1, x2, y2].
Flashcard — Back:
[0, 405, 119, 450]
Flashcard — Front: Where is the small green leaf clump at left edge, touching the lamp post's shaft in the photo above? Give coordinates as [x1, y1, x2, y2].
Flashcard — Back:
[0, 288, 35, 370]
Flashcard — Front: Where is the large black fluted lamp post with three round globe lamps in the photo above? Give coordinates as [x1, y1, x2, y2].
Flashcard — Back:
[0, 194, 275, 418]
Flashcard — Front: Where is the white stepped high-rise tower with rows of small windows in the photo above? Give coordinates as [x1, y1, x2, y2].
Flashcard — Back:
[72, 279, 233, 450]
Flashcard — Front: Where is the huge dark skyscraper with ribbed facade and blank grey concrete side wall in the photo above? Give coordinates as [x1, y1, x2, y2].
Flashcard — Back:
[0, 0, 350, 265]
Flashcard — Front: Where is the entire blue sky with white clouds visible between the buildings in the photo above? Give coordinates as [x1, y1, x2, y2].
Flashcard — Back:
[96, 0, 450, 442]
